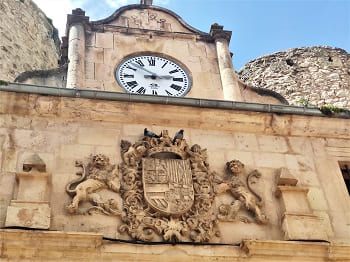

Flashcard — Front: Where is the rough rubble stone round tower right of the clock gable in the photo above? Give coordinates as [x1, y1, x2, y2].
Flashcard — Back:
[238, 47, 350, 108]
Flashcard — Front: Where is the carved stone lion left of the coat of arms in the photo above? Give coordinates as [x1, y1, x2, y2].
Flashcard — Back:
[66, 154, 120, 215]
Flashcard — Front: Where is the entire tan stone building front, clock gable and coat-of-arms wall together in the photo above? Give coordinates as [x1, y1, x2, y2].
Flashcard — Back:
[0, 1, 350, 262]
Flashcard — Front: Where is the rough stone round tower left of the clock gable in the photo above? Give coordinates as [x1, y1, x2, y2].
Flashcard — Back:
[0, 0, 60, 81]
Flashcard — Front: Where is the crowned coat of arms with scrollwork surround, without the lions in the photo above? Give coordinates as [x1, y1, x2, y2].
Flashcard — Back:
[119, 130, 217, 242]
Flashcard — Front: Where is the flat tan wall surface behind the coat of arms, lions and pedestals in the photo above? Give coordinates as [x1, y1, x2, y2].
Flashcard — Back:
[0, 92, 350, 246]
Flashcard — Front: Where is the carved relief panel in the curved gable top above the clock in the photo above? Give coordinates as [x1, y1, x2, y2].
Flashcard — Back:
[121, 10, 172, 31]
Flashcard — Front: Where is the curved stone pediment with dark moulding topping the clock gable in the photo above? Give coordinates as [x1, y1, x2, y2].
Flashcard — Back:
[91, 4, 207, 35]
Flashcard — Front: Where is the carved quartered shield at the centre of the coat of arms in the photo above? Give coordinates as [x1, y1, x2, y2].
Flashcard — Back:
[142, 158, 194, 215]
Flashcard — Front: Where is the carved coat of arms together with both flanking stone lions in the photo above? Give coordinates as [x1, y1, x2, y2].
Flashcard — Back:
[66, 129, 267, 242]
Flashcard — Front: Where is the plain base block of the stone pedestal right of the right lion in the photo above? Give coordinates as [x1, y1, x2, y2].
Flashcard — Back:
[282, 214, 328, 240]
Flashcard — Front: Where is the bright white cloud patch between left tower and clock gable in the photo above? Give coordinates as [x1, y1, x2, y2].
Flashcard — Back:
[33, 0, 86, 37]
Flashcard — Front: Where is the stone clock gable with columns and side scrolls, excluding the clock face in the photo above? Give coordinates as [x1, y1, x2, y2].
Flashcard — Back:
[15, 4, 288, 104]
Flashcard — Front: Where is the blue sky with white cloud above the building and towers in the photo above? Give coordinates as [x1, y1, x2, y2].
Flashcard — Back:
[34, 0, 350, 71]
